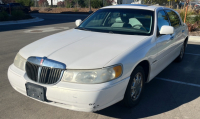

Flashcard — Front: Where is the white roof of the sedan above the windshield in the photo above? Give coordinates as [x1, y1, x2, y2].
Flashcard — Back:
[101, 4, 164, 11]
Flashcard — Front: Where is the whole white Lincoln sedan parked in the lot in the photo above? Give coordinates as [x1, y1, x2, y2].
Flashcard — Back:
[8, 4, 188, 112]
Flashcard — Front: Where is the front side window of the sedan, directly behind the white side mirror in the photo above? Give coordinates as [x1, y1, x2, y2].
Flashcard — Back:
[157, 10, 169, 36]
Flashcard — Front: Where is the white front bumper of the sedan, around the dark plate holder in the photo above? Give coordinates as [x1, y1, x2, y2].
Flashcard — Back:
[8, 64, 129, 112]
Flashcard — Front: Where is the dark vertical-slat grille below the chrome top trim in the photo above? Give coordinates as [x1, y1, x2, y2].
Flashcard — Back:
[26, 61, 64, 84]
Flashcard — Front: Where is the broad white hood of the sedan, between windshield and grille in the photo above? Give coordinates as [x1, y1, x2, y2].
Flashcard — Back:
[20, 29, 147, 69]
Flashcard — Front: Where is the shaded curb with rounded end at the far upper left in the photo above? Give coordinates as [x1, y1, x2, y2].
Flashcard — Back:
[0, 17, 44, 26]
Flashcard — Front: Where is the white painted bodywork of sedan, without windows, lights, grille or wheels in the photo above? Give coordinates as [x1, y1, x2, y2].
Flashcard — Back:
[8, 5, 188, 112]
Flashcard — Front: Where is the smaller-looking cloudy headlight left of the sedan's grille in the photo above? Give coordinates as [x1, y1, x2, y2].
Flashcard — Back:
[14, 53, 26, 71]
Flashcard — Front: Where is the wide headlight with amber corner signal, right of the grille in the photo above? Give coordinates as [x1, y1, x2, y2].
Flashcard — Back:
[62, 65, 122, 84]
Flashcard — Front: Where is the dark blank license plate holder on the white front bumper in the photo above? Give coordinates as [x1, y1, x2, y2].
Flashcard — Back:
[25, 83, 47, 101]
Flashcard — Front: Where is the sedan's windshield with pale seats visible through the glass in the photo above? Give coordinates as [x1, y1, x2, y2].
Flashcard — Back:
[76, 9, 154, 36]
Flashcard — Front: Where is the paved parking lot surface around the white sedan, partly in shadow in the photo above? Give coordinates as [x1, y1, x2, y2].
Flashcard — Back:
[0, 14, 200, 119]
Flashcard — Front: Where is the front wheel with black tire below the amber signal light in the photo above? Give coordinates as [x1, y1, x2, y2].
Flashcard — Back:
[122, 66, 145, 107]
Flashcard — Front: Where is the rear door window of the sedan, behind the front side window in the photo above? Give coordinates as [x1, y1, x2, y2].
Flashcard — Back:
[166, 10, 181, 27]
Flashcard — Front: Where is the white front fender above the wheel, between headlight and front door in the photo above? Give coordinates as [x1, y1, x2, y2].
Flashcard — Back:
[105, 36, 157, 81]
